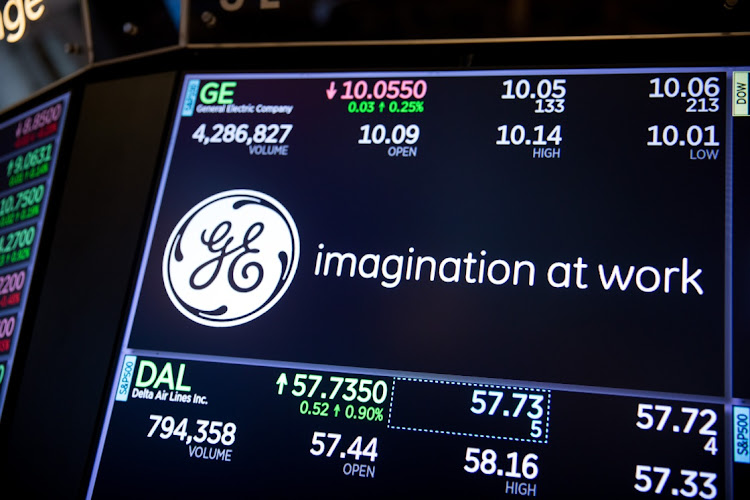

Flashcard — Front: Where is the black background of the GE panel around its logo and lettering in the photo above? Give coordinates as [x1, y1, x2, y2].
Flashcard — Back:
[129, 75, 724, 395]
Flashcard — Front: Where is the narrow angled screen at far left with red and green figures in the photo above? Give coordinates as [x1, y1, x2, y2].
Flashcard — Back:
[0, 94, 69, 418]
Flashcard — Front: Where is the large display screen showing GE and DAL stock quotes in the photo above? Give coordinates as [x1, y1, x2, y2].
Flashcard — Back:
[88, 67, 750, 499]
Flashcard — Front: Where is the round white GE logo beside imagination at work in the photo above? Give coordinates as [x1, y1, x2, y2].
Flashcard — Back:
[162, 189, 299, 326]
